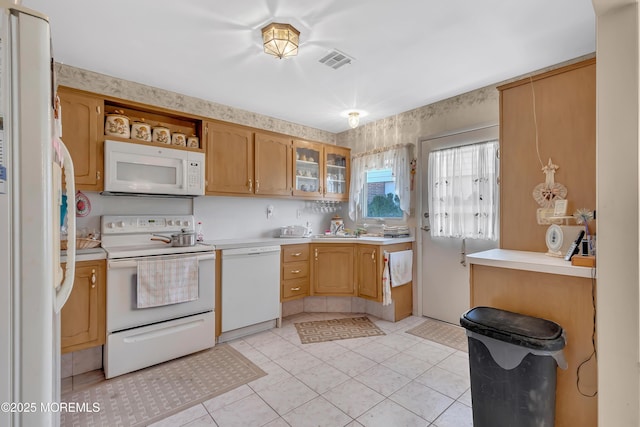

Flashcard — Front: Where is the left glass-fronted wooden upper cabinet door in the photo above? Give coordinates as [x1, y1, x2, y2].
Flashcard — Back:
[293, 141, 324, 197]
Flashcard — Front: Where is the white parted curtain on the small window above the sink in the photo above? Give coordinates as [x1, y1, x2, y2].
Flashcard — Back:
[349, 144, 413, 221]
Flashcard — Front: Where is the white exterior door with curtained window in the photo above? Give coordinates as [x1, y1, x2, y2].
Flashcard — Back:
[420, 126, 499, 324]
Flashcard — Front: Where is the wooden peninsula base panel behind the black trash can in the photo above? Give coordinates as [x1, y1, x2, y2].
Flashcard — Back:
[470, 264, 598, 427]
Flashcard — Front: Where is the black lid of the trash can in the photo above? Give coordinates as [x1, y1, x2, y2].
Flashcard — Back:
[460, 307, 565, 351]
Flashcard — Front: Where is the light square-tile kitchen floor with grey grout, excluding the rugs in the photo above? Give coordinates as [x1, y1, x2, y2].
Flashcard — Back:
[148, 313, 473, 427]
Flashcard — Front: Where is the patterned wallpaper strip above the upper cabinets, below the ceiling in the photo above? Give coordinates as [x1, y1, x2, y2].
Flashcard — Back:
[56, 64, 336, 144]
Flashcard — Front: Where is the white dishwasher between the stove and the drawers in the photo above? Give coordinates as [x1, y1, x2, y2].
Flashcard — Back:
[220, 246, 280, 341]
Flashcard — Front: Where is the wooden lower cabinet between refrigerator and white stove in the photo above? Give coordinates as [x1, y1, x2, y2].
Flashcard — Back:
[60, 260, 106, 353]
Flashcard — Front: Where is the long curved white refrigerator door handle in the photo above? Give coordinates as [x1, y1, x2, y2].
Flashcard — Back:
[54, 140, 76, 313]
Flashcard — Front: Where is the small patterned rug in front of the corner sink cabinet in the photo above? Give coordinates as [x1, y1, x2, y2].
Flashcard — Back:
[294, 317, 385, 344]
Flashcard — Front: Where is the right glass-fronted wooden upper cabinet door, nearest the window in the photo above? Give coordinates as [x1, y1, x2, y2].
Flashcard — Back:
[323, 145, 351, 201]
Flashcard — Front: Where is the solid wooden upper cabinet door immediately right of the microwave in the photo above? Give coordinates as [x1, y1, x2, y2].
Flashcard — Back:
[204, 122, 254, 194]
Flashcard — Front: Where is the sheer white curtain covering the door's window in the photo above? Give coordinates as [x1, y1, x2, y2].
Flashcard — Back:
[428, 141, 499, 240]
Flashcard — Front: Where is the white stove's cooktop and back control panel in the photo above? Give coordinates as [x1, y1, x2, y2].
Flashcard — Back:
[101, 215, 215, 259]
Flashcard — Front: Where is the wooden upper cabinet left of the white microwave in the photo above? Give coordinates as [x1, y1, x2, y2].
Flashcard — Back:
[58, 87, 104, 191]
